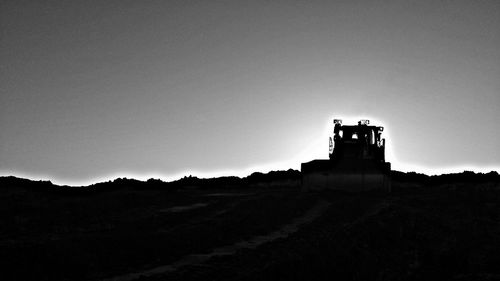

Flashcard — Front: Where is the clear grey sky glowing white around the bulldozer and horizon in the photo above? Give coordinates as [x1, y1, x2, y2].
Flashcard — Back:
[0, 0, 500, 184]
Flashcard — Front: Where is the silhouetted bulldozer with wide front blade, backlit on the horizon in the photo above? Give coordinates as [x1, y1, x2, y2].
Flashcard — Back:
[301, 119, 391, 192]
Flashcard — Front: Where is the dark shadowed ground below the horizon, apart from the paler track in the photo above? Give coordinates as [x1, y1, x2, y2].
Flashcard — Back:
[0, 172, 500, 280]
